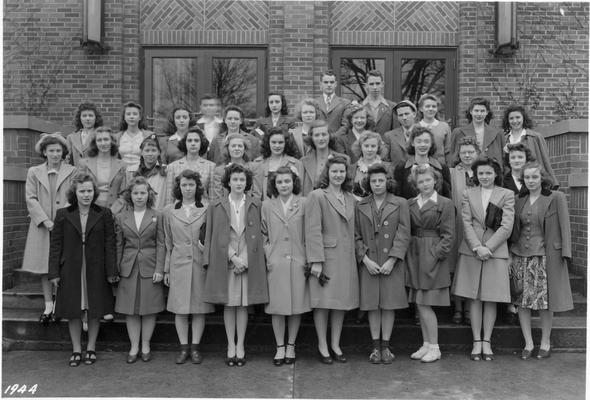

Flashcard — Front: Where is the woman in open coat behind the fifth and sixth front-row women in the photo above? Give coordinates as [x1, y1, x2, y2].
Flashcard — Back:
[301, 120, 349, 196]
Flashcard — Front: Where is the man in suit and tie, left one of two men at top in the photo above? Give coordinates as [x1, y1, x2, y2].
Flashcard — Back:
[316, 70, 350, 135]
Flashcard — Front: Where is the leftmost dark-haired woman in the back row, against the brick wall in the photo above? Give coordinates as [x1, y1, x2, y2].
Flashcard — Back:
[66, 103, 102, 167]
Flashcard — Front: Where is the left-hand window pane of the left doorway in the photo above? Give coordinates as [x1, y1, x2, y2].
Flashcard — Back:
[152, 58, 198, 132]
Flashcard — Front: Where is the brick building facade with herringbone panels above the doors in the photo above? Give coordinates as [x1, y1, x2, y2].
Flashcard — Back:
[4, 0, 589, 284]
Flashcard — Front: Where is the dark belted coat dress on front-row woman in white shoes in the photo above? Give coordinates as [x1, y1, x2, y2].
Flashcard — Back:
[406, 192, 455, 306]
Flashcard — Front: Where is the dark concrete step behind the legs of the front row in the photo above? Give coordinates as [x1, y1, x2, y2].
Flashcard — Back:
[2, 308, 586, 351]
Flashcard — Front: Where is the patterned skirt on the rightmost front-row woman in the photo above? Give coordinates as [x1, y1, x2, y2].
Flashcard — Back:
[510, 255, 549, 310]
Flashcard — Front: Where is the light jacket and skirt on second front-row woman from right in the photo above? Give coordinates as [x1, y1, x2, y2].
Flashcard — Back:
[451, 186, 514, 303]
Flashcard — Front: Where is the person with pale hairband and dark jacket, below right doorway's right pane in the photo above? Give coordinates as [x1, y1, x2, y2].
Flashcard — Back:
[383, 100, 416, 166]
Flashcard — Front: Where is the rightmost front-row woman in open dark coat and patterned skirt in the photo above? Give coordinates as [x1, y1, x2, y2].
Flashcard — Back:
[510, 162, 574, 360]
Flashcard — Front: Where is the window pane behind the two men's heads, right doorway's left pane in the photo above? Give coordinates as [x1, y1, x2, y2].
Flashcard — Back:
[340, 58, 385, 102]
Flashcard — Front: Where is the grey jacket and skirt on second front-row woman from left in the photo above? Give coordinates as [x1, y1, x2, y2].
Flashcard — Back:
[115, 208, 164, 315]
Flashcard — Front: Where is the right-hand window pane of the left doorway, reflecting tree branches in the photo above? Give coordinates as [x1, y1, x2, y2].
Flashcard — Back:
[212, 58, 258, 118]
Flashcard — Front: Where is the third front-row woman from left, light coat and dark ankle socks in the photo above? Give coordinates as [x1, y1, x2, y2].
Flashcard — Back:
[157, 170, 214, 364]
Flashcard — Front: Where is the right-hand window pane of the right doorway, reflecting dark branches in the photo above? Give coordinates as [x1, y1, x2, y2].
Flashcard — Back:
[402, 58, 447, 121]
